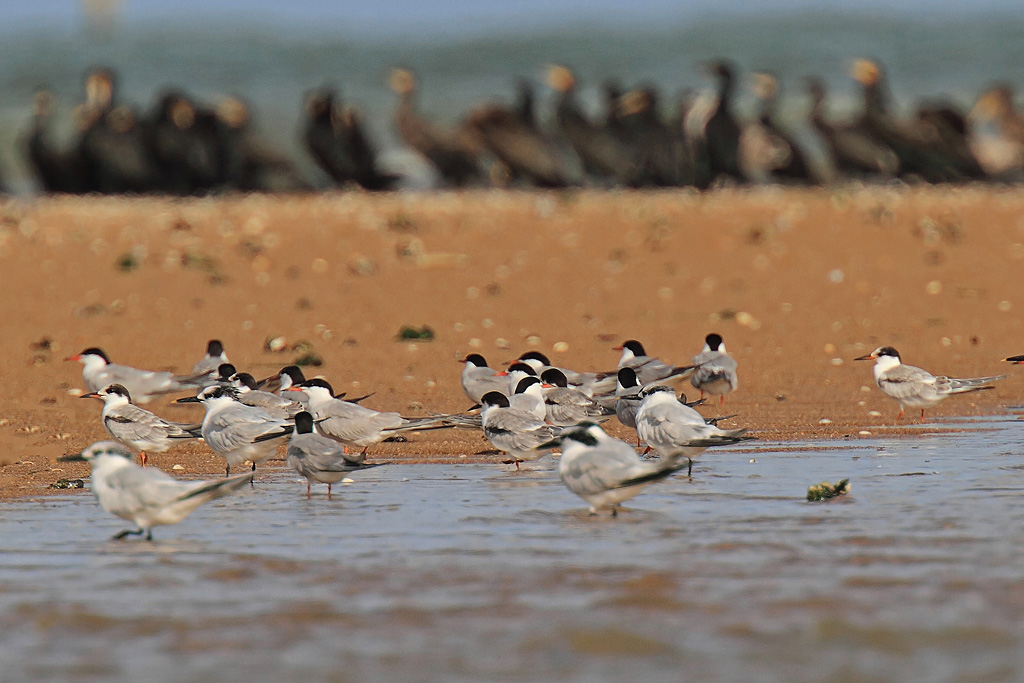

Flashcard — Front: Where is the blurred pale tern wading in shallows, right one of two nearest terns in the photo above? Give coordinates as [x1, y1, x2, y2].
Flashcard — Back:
[538, 422, 685, 516]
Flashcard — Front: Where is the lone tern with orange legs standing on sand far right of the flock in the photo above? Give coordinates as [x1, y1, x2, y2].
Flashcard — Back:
[854, 346, 1007, 422]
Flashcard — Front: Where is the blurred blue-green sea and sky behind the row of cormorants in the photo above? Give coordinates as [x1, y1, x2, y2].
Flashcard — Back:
[0, 0, 1024, 193]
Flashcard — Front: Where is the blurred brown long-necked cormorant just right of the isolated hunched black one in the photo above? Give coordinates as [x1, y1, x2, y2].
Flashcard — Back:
[388, 69, 483, 187]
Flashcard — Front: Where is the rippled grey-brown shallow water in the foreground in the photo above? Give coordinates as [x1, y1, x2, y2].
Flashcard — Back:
[6, 417, 1024, 681]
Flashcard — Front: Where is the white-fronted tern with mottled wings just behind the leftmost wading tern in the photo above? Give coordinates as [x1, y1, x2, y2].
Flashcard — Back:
[80, 384, 202, 467]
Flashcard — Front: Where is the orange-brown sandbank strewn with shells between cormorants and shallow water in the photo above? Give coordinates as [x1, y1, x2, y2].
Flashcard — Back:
[0, 187, 1024, 498]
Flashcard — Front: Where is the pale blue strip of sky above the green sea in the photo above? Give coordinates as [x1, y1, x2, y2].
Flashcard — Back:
[8, 0, 1024, 38]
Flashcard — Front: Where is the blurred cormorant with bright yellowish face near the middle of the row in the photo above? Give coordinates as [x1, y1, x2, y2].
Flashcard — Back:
[548, 67, 638, 185]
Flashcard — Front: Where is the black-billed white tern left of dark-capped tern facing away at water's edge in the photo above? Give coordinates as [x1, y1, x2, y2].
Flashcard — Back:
[176, 386, 294, 476]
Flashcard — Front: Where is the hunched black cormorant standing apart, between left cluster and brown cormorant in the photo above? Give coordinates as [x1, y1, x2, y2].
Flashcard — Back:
[303, 87, 399, 190]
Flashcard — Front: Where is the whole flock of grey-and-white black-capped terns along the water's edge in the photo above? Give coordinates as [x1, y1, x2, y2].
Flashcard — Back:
[63, 334, 1024, 539]
